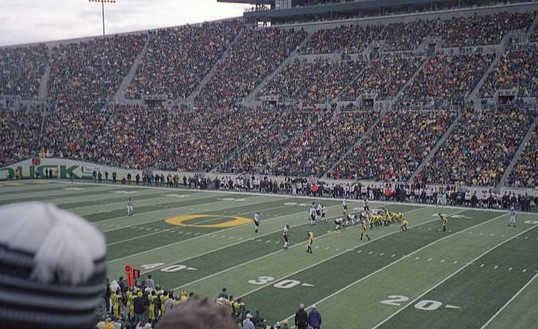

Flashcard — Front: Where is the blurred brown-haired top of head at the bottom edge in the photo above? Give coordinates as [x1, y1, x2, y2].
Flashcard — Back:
[156, 298, 238, 329]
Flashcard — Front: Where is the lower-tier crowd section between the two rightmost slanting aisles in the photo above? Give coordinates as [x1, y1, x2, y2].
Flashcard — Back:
[419, 108, 534, 186]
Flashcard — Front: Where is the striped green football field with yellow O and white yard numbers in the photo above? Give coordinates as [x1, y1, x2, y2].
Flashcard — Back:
[0, 181, 538, 329]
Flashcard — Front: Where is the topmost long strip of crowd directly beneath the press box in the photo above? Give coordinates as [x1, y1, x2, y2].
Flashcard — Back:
[300, 12, 536, 54]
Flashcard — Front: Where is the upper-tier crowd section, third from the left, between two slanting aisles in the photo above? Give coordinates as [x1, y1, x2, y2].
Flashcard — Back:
[126, 20, 241, 99]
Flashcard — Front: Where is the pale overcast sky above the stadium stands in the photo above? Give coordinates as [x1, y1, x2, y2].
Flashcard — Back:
[0, 0, 248, 46]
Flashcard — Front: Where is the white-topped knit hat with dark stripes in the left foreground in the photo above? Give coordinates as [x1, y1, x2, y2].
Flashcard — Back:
[0, 202, 106, 329]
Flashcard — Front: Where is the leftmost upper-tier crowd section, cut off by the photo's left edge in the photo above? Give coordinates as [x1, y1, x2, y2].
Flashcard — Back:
[0, 44, 49, 99]
